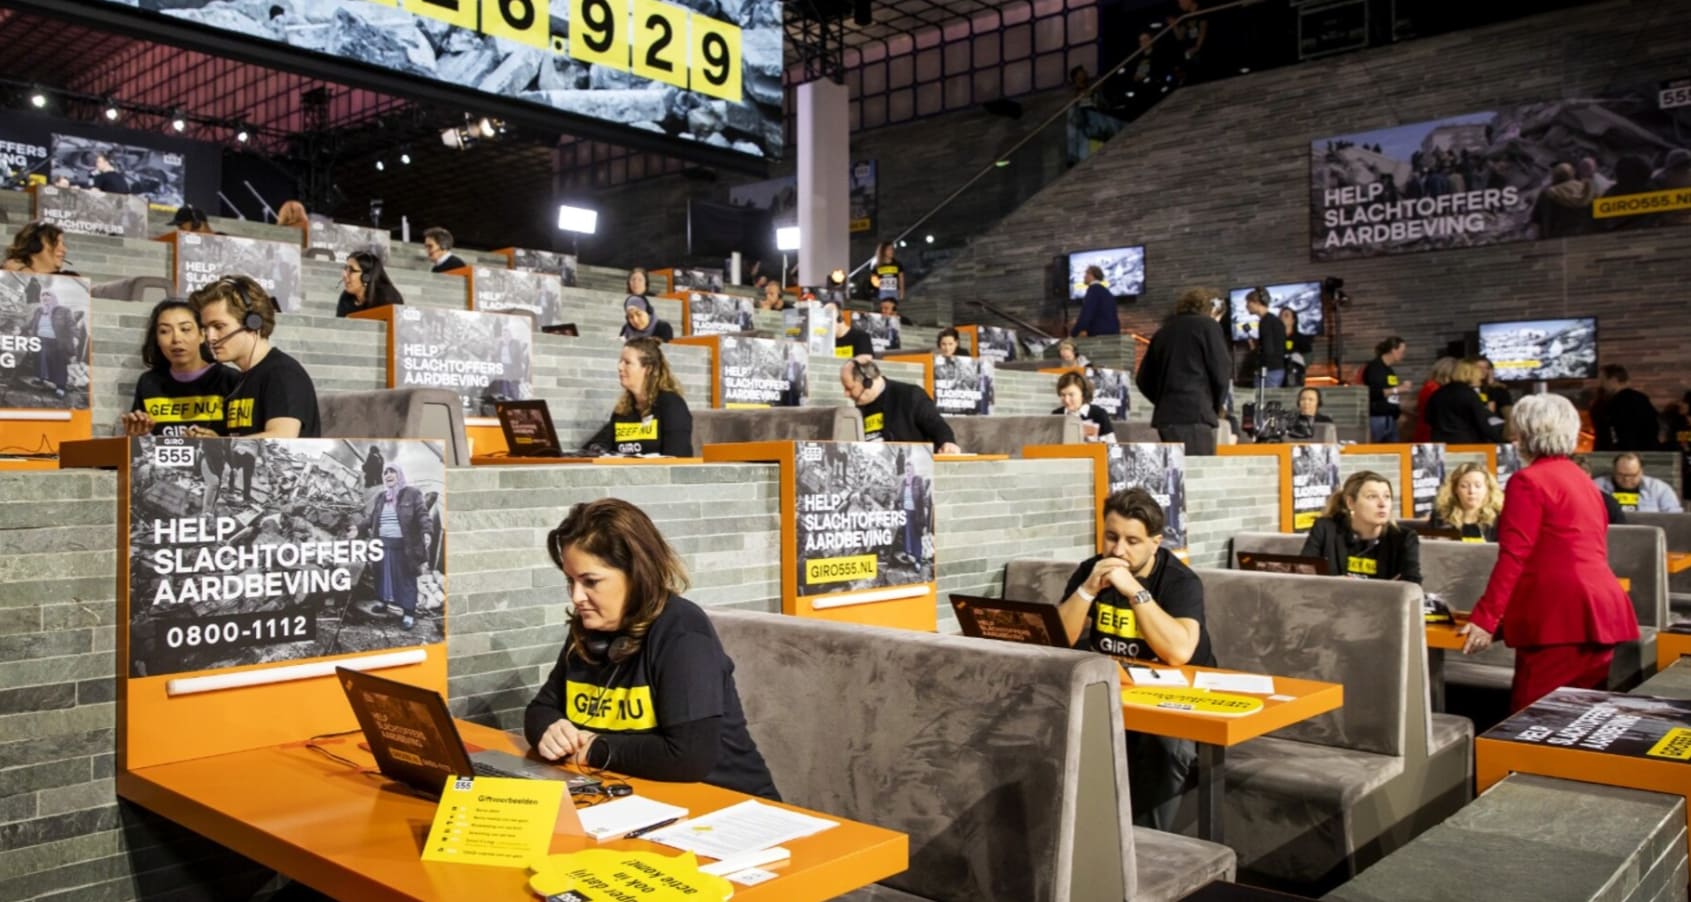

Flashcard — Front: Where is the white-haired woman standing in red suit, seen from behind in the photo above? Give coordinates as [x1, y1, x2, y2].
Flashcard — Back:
[1463, 394, 1639, 711]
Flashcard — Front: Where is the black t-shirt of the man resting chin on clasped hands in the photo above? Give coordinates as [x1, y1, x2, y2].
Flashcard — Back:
[1062, 548, 1216, 667]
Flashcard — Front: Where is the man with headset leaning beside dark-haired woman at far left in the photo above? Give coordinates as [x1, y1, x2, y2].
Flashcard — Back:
[188, 276, 323, 438]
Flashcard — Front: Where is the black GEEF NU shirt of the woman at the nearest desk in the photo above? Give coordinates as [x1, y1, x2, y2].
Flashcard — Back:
[524, 596, 780, 799]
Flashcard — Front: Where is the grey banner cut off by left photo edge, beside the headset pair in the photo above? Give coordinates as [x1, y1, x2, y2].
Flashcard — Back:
[0, 272, 91, 409]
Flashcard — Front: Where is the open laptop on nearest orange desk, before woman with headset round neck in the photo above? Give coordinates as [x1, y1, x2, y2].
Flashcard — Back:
[335, 667, 599, 797]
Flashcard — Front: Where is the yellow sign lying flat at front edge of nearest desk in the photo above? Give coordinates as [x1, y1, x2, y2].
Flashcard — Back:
[529, 850, 734, 902]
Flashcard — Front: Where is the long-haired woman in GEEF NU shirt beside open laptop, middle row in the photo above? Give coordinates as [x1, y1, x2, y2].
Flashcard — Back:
[587, 338, 693, 457]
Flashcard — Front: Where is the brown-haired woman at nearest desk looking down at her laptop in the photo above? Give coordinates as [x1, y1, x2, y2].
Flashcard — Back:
[523, 498, 781, 800]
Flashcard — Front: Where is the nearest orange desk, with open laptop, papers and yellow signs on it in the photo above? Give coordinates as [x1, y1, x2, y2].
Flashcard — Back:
[117, 721, 910, 902]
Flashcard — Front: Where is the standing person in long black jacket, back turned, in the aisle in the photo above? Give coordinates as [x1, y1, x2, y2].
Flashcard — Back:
[1135, 288, 1233, 455]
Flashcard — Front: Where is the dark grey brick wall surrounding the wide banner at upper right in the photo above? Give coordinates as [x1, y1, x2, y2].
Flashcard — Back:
[913, 0, 1691, 403]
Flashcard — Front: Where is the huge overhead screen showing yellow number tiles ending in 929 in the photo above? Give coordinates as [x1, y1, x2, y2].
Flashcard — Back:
[88, 0, 783, 159]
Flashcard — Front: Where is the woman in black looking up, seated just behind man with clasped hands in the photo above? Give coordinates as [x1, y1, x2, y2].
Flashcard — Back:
[1304, 470, 1420, 584]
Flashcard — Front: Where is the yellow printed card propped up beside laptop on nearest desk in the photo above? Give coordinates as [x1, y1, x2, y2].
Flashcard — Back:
[423, 777, 566, 868]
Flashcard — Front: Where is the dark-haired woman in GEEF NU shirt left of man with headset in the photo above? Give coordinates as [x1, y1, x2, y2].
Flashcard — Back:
[118, 298, 235, 435]
